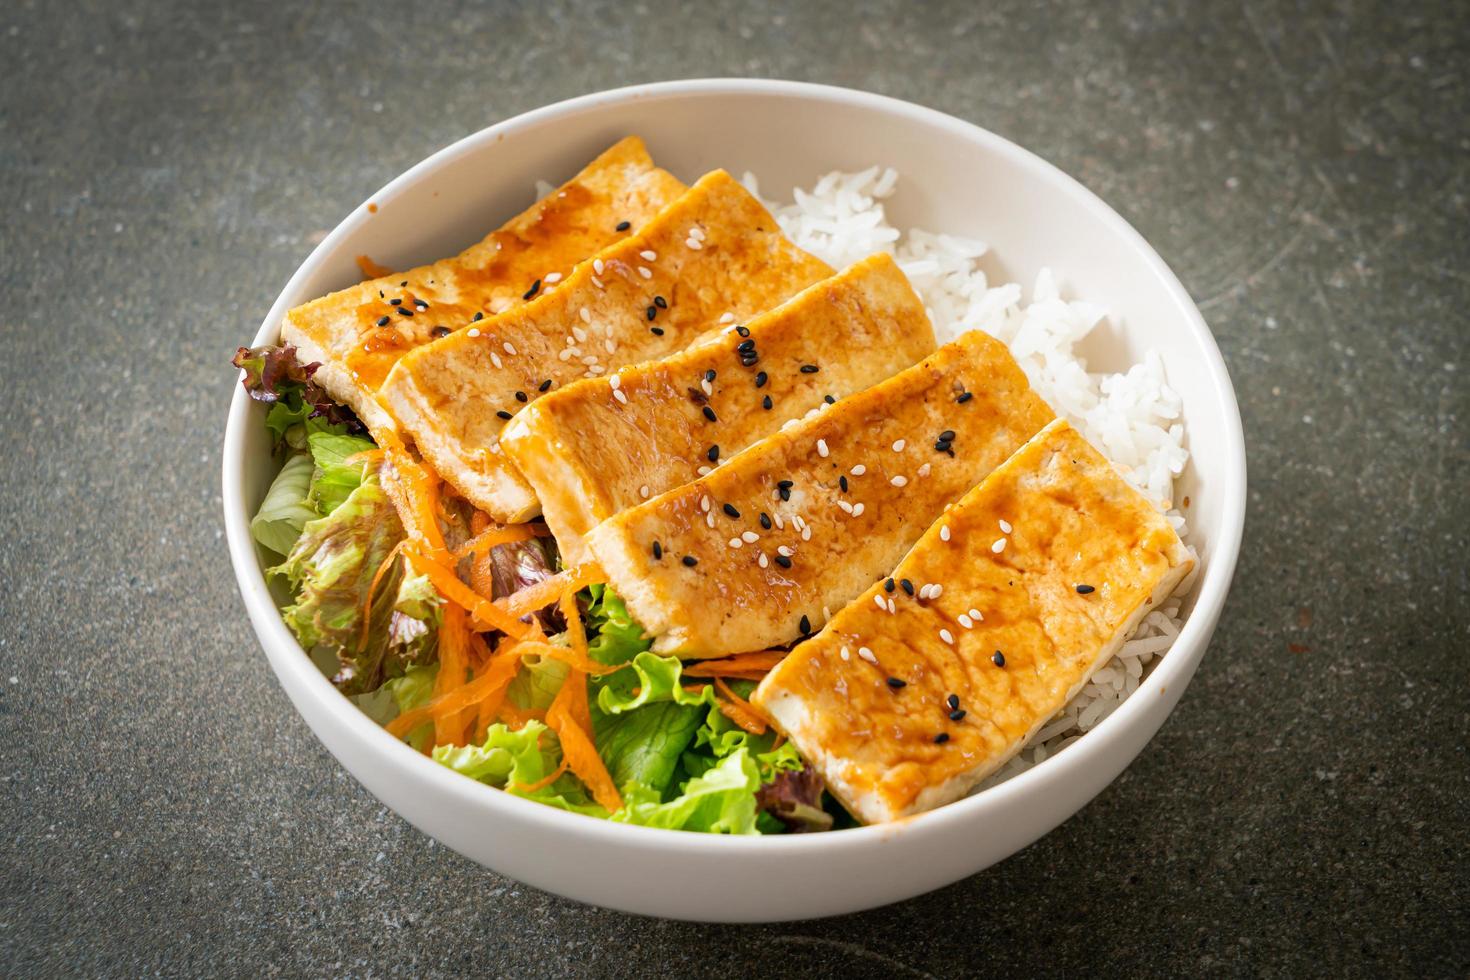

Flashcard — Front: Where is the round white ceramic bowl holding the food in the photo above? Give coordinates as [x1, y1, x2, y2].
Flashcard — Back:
[223, 79, 1245, 921]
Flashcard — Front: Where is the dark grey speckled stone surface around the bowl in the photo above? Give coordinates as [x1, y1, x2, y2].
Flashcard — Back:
[0, 0, 1470, 976]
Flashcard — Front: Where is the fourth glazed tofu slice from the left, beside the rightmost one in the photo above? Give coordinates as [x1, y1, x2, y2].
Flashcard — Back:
[587, 331, 1053, 657]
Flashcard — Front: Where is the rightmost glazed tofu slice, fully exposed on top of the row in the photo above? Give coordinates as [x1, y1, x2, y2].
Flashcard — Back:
[753, 419, 1194, 823]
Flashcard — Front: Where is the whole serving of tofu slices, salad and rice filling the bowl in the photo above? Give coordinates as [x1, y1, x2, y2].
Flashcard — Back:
[234, 137, 1200, 835]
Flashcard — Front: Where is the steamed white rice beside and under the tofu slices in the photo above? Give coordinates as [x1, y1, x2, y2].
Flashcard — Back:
[744, 166, 1200, 785]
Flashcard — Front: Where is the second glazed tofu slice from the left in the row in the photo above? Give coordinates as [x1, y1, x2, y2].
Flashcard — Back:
[382, 170, 832, 522]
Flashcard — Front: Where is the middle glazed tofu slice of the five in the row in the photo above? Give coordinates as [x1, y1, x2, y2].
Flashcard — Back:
[500, 254, 935, 564]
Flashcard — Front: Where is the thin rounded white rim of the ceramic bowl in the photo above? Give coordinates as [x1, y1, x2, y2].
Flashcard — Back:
[221, 78, 1247, 855]
